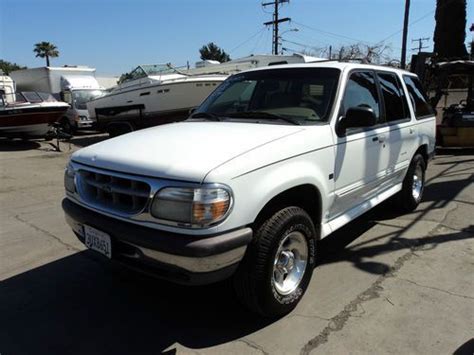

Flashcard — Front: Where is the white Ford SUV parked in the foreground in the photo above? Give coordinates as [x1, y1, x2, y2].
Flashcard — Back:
[63, 61, 435, 316]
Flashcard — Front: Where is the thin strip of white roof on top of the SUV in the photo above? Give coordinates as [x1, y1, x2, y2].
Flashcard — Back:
[241, 60, 415, 76]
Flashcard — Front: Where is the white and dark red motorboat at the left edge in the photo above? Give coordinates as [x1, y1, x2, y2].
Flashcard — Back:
[0, 75, 69, 138]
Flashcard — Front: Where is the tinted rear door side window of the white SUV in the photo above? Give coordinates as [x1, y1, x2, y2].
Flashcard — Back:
[377, 73, 410, 122]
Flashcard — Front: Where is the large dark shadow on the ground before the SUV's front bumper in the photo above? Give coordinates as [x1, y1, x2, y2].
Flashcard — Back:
[0, 252, 268, 354]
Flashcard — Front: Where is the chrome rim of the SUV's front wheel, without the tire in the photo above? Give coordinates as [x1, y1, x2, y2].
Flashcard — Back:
[272, 232, 308, 295]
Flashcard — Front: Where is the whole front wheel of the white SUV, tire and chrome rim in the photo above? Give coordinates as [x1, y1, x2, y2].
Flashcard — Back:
[233, 207, 318, 317]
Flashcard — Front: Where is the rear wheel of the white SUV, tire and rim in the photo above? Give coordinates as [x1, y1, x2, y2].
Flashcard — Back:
[398, 154, 426, 212]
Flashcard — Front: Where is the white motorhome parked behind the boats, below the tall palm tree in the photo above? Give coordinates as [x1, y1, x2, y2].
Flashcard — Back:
[10, 66, 105, 133]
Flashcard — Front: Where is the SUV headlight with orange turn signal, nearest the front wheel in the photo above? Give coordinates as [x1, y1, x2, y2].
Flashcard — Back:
[151, 187, 231, 227]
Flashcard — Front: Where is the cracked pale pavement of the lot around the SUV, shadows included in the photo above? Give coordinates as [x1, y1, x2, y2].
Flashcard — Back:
[0, 136, 474, 355]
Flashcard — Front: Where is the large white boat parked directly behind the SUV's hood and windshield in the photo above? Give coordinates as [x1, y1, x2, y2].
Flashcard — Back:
[87, 54, 321, 133]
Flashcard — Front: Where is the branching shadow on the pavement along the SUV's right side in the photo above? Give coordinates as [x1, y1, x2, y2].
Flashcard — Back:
[320, 157, 474, 275]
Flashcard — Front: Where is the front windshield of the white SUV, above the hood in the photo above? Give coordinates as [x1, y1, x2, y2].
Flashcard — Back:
[193, 68, 340, 124]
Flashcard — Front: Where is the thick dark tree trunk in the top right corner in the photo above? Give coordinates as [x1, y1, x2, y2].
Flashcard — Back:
[433, 0, 467, 59]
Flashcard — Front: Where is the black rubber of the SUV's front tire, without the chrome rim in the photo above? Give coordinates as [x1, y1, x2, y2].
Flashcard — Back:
[233, 207, 318, 317]
